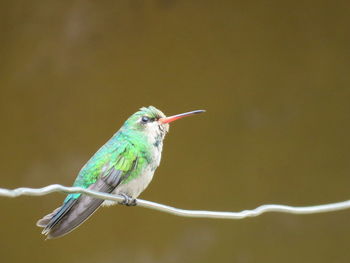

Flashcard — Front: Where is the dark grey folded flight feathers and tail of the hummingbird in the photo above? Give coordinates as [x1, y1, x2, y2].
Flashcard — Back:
[37, 168, 123, 239]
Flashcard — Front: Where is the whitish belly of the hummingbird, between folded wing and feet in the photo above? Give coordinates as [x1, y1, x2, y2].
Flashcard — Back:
[103, 167, 154, 206]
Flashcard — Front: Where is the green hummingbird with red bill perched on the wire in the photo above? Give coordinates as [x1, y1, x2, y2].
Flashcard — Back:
[36, 106, 204, 239]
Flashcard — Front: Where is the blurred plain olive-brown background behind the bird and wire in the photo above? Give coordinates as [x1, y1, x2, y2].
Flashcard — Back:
[0, 0, 350, 263]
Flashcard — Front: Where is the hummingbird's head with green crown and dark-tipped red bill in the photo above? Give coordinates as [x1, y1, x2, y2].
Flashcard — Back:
[124, 106, 204, 144]
